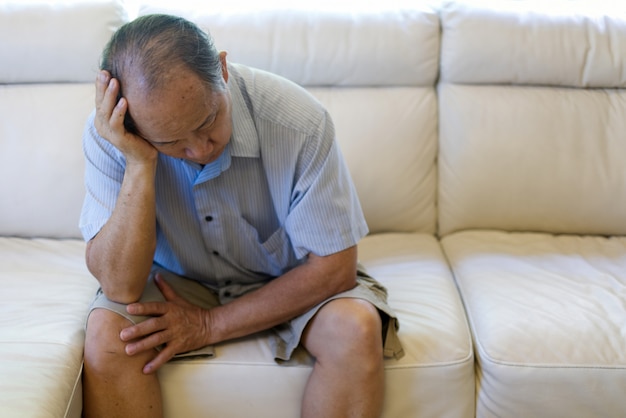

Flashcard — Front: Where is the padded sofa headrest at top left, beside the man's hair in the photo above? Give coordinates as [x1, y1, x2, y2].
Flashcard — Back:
[0, 0, 127, 83]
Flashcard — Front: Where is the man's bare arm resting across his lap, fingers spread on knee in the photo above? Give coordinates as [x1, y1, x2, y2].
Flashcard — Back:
[120, 246, 357, 373]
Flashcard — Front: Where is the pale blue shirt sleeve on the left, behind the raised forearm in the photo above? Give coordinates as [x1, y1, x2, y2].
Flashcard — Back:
[79, 111, 126, 241]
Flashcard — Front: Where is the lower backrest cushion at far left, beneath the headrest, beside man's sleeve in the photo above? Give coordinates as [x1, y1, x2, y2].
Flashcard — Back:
[0, 83, 95, 238]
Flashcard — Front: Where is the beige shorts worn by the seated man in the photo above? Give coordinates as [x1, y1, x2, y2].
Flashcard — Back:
[89, 270, 403, 361]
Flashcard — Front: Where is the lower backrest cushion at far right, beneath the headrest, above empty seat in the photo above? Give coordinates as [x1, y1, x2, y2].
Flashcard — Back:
[439, 84, 626, 235]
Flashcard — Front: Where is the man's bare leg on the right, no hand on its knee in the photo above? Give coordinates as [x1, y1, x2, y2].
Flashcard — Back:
[302, 298, 384, 418]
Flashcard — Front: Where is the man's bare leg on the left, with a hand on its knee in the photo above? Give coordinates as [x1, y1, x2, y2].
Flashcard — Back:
[83, 309, 163, 418]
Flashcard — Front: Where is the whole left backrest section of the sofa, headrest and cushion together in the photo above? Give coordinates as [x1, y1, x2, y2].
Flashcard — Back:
[0, 0, 126, 238]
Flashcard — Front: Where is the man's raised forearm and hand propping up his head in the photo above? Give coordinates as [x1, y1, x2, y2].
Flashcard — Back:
[86, 71, 158, 303]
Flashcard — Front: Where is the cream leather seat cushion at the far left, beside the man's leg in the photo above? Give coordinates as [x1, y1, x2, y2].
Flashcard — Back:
[0, 238, 98, 417]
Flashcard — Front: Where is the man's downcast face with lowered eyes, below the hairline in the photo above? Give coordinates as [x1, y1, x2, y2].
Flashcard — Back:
[126, 63, 232, 165]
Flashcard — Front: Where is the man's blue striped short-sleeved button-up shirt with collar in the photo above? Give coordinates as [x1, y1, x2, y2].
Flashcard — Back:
[80, 64, 368, 296]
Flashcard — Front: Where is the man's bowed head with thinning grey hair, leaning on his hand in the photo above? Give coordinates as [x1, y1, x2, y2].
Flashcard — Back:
[101, 15, 232, 164]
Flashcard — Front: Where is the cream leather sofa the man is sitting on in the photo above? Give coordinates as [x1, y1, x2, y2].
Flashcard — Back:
[0, 0, 626, 418]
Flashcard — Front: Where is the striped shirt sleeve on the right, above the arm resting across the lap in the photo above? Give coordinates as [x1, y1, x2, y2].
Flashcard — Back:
[285, 111, 368, 258]
